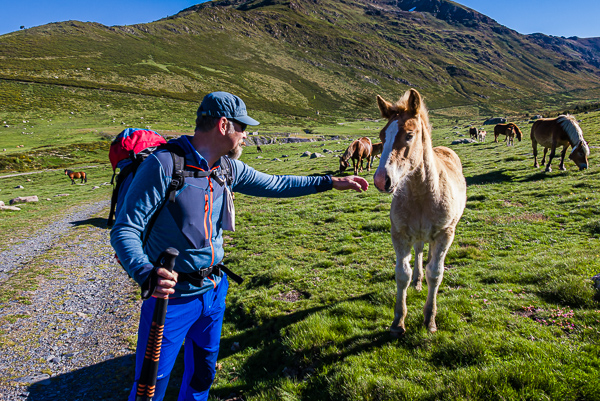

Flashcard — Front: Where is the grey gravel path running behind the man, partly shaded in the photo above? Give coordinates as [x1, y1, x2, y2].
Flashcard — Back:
[0, 201, 140, 400]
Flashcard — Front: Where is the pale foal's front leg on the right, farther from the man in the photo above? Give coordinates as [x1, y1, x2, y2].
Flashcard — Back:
[423, 228, 454, 333]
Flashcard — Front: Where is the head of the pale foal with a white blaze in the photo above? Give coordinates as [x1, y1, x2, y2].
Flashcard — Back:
[374, 89, 430, 193]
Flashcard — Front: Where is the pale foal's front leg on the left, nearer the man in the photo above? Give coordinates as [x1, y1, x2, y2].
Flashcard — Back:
[390, 235, 412, 337]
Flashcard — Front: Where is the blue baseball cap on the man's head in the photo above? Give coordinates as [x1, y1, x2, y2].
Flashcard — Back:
[196, 92, 260, 131]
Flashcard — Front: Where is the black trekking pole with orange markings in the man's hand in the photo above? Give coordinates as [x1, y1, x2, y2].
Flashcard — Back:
[135, 248, 179, 401]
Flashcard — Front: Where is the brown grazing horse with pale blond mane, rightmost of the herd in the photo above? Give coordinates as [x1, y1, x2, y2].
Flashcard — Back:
[531, 115, 590, 172]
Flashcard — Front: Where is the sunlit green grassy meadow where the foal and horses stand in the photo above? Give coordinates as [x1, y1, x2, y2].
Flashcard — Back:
[0, 104, 600, 401]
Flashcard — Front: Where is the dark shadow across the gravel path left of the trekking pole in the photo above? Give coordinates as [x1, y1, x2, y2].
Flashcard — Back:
[27, 350, 135, 401]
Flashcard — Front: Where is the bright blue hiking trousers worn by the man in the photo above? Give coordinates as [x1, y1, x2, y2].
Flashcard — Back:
[129, 274, 229, 401]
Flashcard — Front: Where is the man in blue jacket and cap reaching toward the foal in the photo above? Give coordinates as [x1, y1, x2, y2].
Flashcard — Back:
[111, 92, 368, 401]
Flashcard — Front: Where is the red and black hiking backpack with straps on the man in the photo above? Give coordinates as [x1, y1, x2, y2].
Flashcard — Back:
[107, 128, 233, 228]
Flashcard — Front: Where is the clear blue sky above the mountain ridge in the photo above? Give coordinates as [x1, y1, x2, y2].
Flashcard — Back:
[0, 0, 600, 38]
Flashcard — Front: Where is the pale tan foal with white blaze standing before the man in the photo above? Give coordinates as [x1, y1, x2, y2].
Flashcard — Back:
[374, 89, 467, 336]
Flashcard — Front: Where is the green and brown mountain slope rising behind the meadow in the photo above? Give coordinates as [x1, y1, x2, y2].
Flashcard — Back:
[0, 0, 600, 115]
